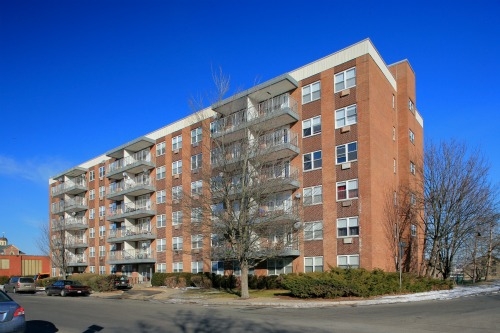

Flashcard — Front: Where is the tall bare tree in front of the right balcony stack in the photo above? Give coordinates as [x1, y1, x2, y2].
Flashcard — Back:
[183, 68, 300, 298]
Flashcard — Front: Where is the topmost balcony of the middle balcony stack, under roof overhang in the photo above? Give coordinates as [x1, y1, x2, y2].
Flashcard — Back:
[106, 149, 155, 179]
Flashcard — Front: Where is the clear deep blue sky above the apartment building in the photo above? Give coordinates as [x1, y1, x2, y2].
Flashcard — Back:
[0, 0, 500, 254]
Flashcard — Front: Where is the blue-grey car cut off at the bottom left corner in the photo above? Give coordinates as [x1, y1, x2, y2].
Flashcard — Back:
[0, 291, 26, 333]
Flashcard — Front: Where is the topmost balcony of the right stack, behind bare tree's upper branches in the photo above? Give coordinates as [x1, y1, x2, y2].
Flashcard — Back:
[211, 94, 299, 142]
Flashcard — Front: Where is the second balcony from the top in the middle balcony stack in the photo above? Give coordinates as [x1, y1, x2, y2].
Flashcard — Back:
[106, 175, 156, 201]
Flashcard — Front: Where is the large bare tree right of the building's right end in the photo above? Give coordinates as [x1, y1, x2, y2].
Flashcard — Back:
[424, 141, 493, 278]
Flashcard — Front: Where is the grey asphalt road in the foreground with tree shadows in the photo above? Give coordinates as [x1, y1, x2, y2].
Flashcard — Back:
[11, 293, 500, 333]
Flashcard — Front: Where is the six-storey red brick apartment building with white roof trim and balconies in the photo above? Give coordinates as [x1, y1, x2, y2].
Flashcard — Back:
[49, 40, 423, 280]
